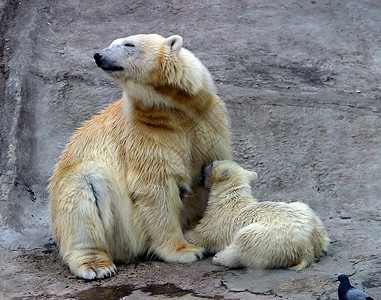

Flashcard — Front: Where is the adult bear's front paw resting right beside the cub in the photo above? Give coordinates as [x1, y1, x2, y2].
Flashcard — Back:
[161, 241, 207, 264]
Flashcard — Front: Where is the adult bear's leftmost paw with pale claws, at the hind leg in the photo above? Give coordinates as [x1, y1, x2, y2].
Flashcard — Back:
[69, 255, 117, 280]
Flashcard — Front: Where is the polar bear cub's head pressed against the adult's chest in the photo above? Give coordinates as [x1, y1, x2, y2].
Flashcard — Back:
[202, 160, 258, 190]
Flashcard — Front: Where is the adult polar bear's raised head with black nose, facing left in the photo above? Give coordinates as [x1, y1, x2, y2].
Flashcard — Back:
[94, 34, 214, 95]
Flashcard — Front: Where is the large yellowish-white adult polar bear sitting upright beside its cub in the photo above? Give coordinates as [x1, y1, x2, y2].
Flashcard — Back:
[49, 34, 231, 279]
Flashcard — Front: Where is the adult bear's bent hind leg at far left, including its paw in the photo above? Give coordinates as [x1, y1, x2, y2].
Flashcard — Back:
[50, 163, 116, 280]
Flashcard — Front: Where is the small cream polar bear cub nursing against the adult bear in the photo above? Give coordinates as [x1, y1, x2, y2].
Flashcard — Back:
[185, 160, 329, 270]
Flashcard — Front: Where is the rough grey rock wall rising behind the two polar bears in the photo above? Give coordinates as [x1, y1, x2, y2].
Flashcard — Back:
[0, 0, 381, 253]
